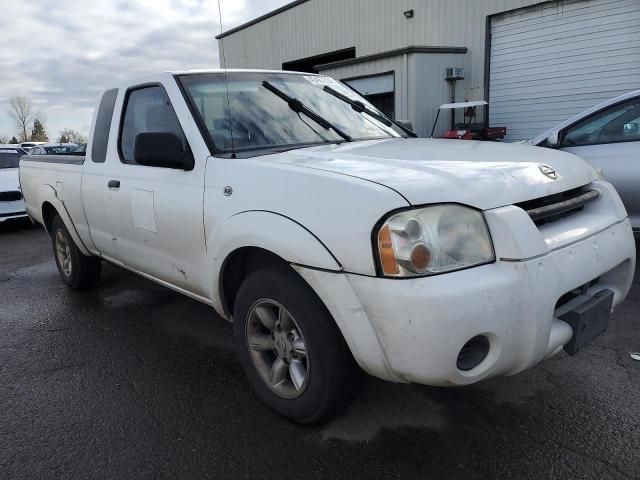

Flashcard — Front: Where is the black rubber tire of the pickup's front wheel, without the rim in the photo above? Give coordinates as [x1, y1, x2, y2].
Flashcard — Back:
[234, 265, 362, 424]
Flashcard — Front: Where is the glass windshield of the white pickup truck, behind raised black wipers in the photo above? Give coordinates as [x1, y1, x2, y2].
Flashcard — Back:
[180, 72, 404, 152]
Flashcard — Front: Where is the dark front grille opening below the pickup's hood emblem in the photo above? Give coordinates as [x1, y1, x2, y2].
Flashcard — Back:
[516, 187, 600, 226]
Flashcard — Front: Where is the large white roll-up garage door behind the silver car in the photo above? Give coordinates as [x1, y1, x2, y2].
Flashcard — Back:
[489, 0, 640, 141]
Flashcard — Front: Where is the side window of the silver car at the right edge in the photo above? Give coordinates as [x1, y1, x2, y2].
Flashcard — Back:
[561, 98, 640, 147]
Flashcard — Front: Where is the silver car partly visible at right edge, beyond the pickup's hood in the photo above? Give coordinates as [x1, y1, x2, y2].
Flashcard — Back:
[531, 90, 640, 234]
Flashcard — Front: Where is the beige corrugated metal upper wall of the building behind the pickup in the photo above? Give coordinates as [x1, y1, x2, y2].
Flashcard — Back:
[222, 0, 540, 100]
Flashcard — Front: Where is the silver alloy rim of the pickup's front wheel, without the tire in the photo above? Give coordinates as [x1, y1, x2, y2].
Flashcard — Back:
[246, 299, 309, 399]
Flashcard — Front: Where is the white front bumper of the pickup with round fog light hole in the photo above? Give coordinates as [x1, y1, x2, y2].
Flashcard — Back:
[297, 219, 635, 386]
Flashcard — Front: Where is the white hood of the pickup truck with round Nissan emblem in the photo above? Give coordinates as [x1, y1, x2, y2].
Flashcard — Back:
[269, 138, 598, 210]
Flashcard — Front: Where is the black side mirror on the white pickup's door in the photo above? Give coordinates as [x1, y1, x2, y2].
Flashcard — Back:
[133, 132, 195, 170]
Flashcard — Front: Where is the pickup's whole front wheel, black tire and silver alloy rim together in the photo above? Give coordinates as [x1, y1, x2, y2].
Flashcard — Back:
[234, 266, 362, 423]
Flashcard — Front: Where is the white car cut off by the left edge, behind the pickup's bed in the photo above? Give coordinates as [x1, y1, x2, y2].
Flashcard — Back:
[0, 145, 27, 223]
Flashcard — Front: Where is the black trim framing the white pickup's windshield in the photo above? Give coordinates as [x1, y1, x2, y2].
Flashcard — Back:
[172, 72, 409, 158]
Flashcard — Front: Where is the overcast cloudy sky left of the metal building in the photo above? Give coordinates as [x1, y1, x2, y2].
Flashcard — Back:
[0, 0, 288, 140]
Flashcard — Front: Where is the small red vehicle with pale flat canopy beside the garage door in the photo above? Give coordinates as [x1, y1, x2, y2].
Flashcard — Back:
[431, 100, 507, 141]
